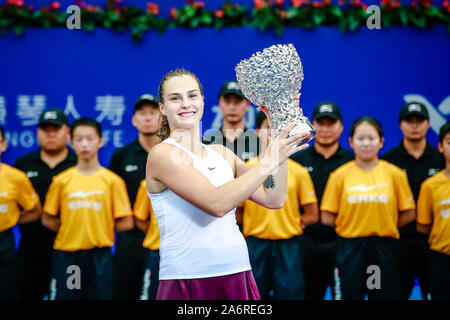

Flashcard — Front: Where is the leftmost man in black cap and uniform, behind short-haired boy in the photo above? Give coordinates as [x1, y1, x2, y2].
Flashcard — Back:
[14, 108, 77, 300]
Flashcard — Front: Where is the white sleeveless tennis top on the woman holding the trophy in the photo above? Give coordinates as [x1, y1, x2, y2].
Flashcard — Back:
[148, 138, 251, 280]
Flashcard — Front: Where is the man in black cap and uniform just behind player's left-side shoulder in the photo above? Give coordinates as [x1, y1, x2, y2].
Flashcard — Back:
[109, 94, 161, 300]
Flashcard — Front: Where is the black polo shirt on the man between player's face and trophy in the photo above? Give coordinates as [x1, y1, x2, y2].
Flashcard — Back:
[202, 128, 259, 162]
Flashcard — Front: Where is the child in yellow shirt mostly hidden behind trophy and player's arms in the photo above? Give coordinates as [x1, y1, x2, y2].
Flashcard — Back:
[238, 111, 319, 300]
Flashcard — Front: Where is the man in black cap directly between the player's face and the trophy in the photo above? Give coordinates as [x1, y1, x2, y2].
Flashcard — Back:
[202, 80, 259, 162]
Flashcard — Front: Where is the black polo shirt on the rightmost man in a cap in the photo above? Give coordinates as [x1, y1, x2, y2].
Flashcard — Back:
[381, 141, 445, 236]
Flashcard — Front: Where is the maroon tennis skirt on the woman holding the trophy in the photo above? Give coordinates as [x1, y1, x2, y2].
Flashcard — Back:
[156, 270, 261, 300]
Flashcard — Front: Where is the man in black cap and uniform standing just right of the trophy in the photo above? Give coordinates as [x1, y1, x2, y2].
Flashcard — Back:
[291, 101, 354, 300]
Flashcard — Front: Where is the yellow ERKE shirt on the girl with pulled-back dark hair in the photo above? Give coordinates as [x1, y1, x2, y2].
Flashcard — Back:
[320, 160, 415, 239]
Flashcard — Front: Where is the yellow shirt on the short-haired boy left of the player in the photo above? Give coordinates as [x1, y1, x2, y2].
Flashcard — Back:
[43, 167, 132, 251]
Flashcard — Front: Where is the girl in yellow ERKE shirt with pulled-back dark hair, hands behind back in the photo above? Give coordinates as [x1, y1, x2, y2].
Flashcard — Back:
[320, 117, 415, 300]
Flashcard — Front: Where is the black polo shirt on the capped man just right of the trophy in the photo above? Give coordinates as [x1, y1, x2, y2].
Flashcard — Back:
[291, 146, 354, 241]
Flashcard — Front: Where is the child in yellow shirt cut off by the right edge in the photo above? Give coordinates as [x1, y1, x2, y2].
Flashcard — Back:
[417, 121, 450, 300]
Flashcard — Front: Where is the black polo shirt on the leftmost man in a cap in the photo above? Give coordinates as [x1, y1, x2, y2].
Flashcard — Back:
[14, 150, 77, 256]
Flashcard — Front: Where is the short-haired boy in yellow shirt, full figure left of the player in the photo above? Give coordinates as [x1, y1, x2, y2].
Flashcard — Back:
[42, 118, 133, 300]
